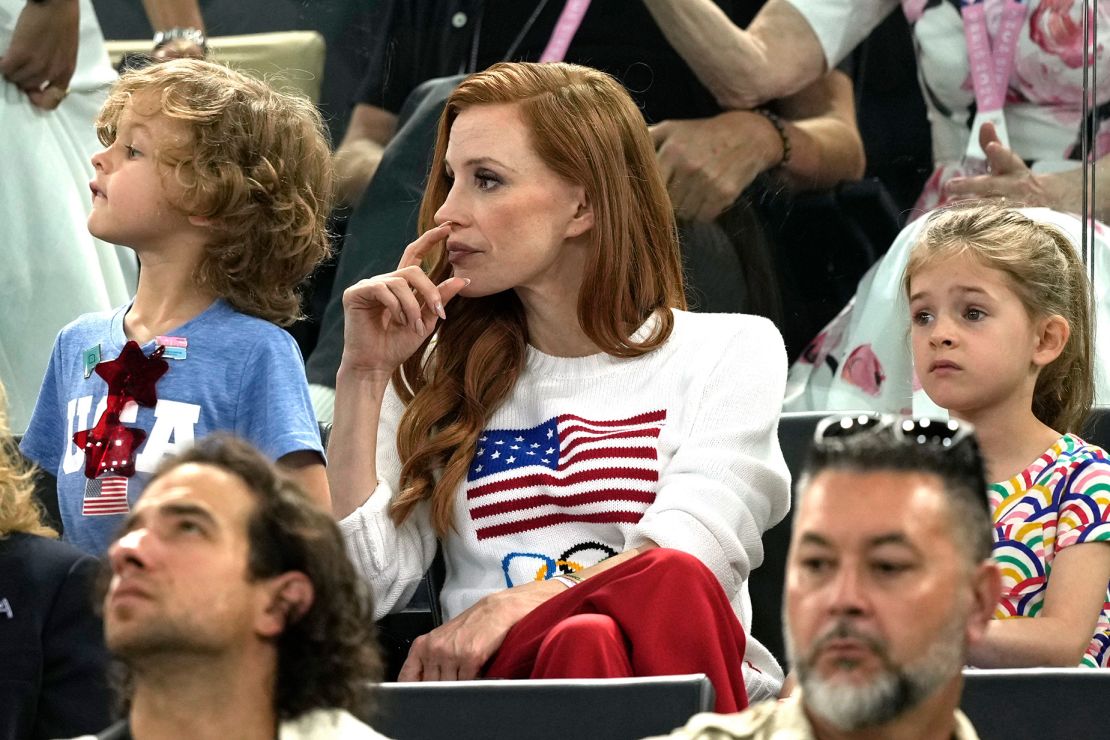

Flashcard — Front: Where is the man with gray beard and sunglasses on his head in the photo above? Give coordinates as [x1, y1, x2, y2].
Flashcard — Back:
[648, 416, 1000, 740]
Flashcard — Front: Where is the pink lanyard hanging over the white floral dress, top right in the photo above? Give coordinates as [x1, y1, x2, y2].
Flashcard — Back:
[960, 0, 1028, 160]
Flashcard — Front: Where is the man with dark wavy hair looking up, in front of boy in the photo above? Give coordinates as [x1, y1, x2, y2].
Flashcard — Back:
[82, 436, 381, 740]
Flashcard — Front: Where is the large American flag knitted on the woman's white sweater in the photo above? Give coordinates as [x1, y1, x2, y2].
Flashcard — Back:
[466, 410, 667, 539]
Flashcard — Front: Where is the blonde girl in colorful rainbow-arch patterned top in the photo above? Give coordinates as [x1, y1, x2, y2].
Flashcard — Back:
[904, 204, 1110, 668]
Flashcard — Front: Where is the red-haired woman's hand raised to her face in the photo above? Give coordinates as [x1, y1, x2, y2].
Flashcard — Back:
[342, 222, 470, 377]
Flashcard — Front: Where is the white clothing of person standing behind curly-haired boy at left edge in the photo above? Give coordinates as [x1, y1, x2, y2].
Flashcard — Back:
[0, 0, 138, 434]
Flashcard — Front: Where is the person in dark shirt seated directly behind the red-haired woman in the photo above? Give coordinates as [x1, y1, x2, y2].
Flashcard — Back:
[307, 0, 869, 418]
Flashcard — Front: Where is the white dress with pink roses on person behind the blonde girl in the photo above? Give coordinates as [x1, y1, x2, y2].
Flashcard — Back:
[784, 0, 1110, 414]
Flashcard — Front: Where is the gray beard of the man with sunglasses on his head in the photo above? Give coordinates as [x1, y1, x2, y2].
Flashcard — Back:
[786, 614, 965, 732]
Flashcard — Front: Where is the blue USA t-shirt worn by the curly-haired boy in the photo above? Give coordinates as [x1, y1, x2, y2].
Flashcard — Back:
[20, 300, 323, 555]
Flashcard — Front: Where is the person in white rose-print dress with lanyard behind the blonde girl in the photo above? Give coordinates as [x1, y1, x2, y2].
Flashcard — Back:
[645, 0, 1110, 410]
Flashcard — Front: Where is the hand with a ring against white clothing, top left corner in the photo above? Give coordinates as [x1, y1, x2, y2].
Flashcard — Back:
[0, 0, 80, 110]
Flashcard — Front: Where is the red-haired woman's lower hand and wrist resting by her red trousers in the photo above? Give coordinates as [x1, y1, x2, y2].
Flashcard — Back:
[397, 580, 566, 681]
